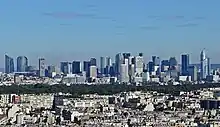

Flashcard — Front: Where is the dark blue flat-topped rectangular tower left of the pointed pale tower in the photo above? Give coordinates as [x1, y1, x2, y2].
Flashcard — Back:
[181, 54, 189, 76]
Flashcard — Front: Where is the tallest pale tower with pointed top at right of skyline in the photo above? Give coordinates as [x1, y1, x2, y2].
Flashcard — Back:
[200, 50, 208, 79]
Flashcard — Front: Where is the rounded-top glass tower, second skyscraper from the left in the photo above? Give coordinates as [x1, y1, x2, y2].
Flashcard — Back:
[17, 56, 28, 72]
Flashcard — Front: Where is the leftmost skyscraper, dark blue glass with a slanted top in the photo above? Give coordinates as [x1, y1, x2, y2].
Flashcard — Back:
[5, 55, 14, 74]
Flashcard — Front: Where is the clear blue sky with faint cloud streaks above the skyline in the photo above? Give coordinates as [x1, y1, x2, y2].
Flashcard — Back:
[0, 0, 220, 66]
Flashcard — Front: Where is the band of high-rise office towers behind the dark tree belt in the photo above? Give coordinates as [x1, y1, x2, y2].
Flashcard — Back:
[5, 50, 219, 85]
